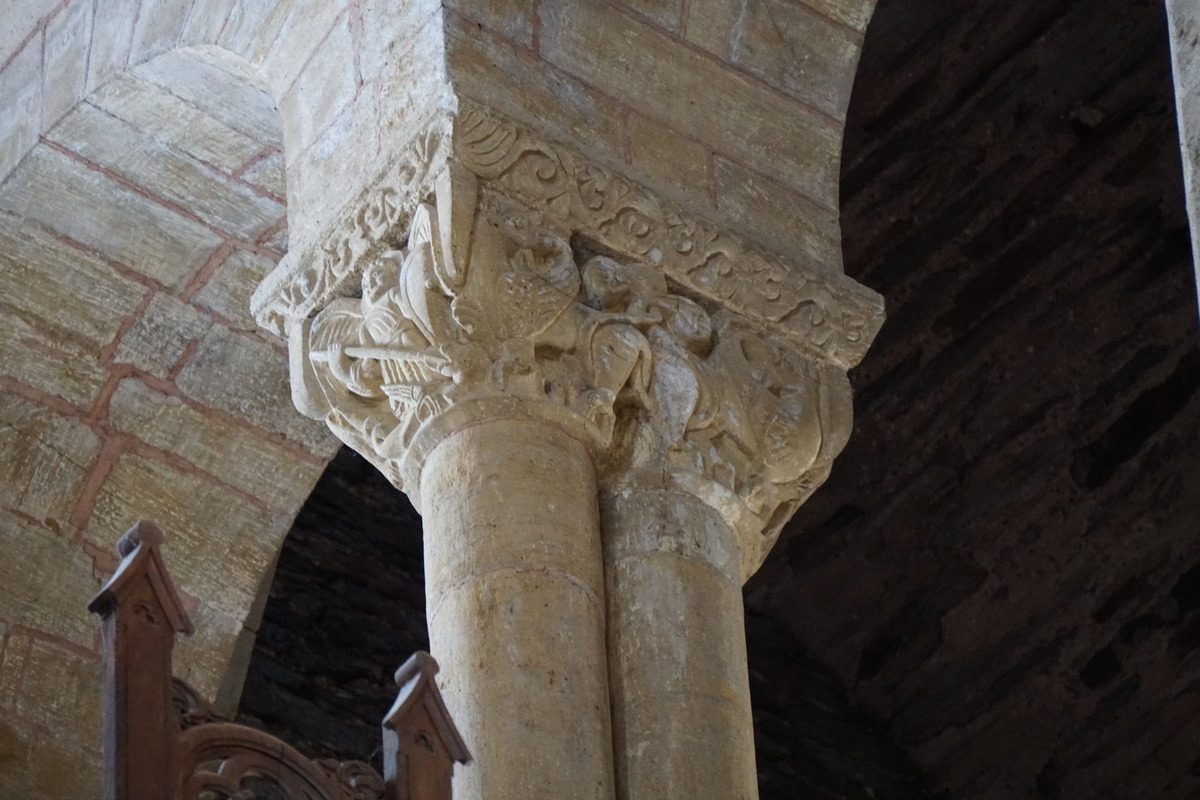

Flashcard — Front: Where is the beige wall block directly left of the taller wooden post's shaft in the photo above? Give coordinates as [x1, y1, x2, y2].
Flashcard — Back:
[17, 638, 103, 753]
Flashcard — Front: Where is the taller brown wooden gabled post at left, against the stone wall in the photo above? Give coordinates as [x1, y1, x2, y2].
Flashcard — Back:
[88, 522, 192, 800]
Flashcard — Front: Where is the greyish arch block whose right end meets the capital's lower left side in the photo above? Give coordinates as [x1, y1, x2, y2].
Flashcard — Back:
[175, 325, 337, 456]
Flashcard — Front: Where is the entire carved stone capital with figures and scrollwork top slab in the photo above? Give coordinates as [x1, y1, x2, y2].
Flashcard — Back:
[254, 106, 883, 576]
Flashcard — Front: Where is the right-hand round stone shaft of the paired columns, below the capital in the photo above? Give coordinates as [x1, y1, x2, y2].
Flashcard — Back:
[601, 488, 758, 800]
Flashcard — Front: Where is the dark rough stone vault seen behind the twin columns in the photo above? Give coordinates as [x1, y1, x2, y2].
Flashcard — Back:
[242, 0, 1200, 800]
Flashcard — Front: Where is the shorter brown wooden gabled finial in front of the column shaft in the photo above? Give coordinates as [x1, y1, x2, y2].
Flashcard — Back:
[383, 652, 470, 800]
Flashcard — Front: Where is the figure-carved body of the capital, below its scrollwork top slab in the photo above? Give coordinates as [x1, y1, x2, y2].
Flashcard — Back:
[292, 173, 850, 570]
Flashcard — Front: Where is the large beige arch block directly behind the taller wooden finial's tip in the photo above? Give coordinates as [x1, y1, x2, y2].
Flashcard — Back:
[86, 453, 290, 618]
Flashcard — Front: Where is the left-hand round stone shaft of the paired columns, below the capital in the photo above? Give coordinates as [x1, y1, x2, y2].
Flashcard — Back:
[421, 420, 614, 800]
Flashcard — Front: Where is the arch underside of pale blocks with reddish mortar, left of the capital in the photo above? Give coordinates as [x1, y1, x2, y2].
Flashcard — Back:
[0, 40, 332, 799]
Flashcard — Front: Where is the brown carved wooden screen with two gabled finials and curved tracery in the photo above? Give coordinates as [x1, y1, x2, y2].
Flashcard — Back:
[88, 522, 470, 800]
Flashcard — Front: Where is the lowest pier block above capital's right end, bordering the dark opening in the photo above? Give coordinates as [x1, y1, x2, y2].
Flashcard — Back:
[713, 156, 842, 273]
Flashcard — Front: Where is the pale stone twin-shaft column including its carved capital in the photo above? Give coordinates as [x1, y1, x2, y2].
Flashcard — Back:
[254, 98, 882, 800]
